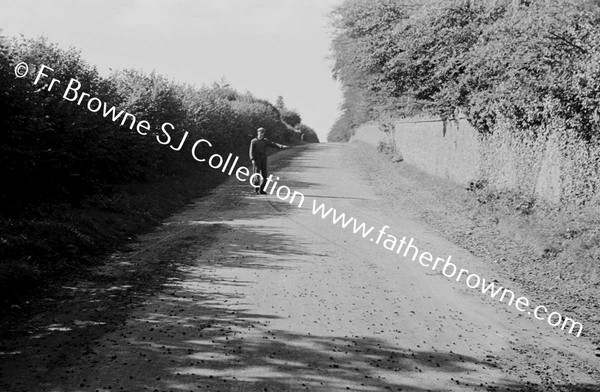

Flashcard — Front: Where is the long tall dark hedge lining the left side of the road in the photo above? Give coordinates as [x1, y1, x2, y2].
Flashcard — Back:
[0, 34, 299, 213]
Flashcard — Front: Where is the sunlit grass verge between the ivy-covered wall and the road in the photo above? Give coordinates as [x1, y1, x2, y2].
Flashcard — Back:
[344, 143, 600, 353]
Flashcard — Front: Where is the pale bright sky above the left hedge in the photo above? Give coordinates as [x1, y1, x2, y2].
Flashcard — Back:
[0, 0, 341, 141]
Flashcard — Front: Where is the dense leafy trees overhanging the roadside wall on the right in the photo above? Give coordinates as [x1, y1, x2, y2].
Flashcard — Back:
[328, 0, 600, 140]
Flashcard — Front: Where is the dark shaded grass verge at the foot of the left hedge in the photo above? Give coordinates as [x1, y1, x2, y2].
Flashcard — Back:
[0, 165, 228, 310]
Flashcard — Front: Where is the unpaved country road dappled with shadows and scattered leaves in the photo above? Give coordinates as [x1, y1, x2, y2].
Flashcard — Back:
[0, 144, 600, 392]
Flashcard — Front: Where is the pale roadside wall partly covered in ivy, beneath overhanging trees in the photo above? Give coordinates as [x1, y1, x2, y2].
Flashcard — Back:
[351, 118, 572, 204]
